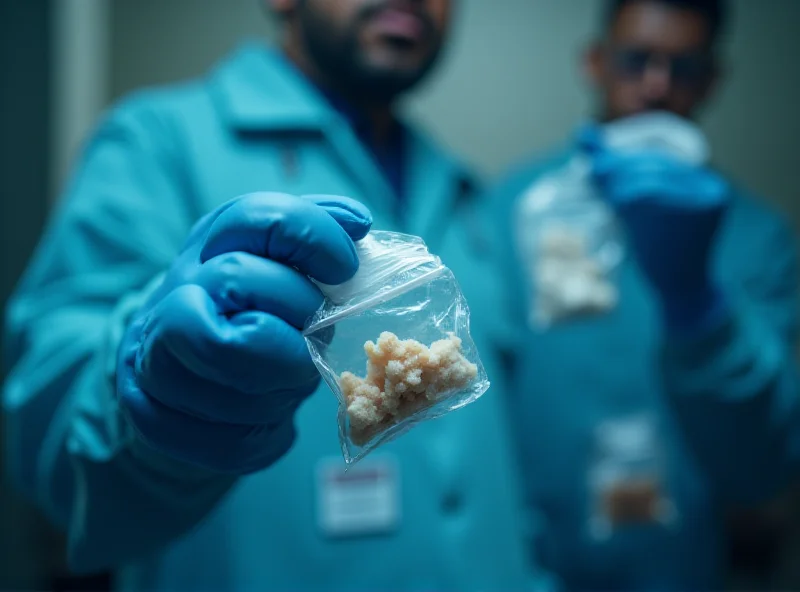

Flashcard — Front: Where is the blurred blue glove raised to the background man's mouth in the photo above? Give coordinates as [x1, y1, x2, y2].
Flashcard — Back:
[579, 126, 730, 334]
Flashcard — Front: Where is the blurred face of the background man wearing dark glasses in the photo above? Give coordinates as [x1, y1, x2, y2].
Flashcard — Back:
[586, 0, 716, 120]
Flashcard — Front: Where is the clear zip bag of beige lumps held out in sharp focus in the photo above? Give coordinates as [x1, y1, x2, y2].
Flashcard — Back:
[304, 231, 489, 464]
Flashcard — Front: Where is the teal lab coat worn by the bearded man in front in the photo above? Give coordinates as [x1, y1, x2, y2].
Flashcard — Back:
[3, 44, 548, 591]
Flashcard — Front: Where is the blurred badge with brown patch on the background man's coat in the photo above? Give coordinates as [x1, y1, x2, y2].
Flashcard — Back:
[589, 414, 677, 540]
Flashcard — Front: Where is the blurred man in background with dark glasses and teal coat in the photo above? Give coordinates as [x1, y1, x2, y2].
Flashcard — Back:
[495, 0, 798, 590]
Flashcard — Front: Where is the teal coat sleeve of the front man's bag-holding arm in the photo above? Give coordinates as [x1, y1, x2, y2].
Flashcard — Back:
[3, 100, 238, 572]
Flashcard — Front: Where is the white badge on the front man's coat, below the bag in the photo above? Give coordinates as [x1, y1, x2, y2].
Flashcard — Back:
[316, 457, 402, 538]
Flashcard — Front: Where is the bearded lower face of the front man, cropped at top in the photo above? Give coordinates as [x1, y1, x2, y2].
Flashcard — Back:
[276, 0, 450, 100]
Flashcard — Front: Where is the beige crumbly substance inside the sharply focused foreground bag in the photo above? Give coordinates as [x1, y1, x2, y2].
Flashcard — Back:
[339, 331, 478, 446]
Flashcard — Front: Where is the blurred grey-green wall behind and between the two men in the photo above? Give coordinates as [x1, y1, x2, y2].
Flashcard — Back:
[110, 0, 800, 227]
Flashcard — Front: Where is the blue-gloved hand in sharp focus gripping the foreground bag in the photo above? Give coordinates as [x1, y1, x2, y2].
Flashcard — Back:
[117, 193, 372, 474]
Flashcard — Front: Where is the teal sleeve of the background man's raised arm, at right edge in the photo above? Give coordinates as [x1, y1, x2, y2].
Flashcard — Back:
[663, 214, 800, 503]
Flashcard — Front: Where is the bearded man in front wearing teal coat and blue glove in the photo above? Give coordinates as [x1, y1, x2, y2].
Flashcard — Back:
[3, 0, 534, 591]
